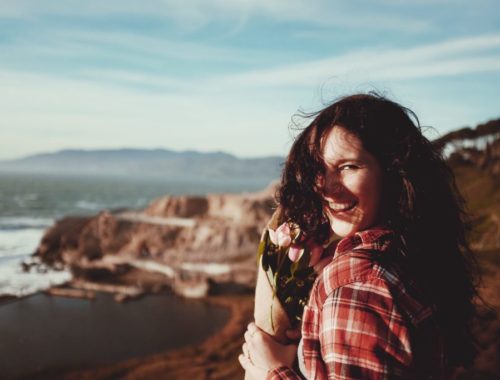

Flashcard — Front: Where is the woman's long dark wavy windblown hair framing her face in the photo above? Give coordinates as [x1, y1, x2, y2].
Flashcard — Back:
[277, 93, 478, 367]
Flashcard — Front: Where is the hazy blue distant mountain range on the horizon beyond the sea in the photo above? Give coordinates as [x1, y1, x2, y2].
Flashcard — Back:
[0, 149, 284, 180]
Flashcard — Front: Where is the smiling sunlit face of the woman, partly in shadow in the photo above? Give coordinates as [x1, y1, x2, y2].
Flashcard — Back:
[318, 126, 382, 237]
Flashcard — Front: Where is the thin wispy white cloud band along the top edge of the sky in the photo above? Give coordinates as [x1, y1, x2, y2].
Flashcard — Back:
[0, 0, 432, 32]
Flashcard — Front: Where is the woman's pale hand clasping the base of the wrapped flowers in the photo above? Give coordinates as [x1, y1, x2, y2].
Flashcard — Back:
[238, 323, 297, 380]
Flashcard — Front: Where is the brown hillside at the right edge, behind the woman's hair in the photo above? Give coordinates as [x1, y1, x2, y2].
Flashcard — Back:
[442, 119, 500, 380]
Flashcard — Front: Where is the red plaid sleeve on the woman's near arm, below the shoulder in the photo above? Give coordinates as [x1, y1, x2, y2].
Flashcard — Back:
[319, 278, 412, 380]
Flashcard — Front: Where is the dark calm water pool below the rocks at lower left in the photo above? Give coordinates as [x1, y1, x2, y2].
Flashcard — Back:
[0, 294, 229, 377]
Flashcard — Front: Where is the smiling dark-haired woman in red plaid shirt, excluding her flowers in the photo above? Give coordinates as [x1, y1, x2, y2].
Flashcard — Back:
[239, 94, 477, 379]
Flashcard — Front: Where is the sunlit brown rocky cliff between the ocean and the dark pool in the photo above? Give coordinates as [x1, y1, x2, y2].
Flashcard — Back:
[35, 184, 276, 295]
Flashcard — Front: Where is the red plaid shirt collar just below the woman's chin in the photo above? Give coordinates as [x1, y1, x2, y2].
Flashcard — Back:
[334, 228, 395, 257]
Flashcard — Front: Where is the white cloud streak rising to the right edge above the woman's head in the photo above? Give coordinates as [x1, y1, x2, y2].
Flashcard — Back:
[215, 35, 500, 87]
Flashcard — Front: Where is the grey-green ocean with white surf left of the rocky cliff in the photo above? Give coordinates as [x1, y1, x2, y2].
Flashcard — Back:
[0, 173, 268, 296]
